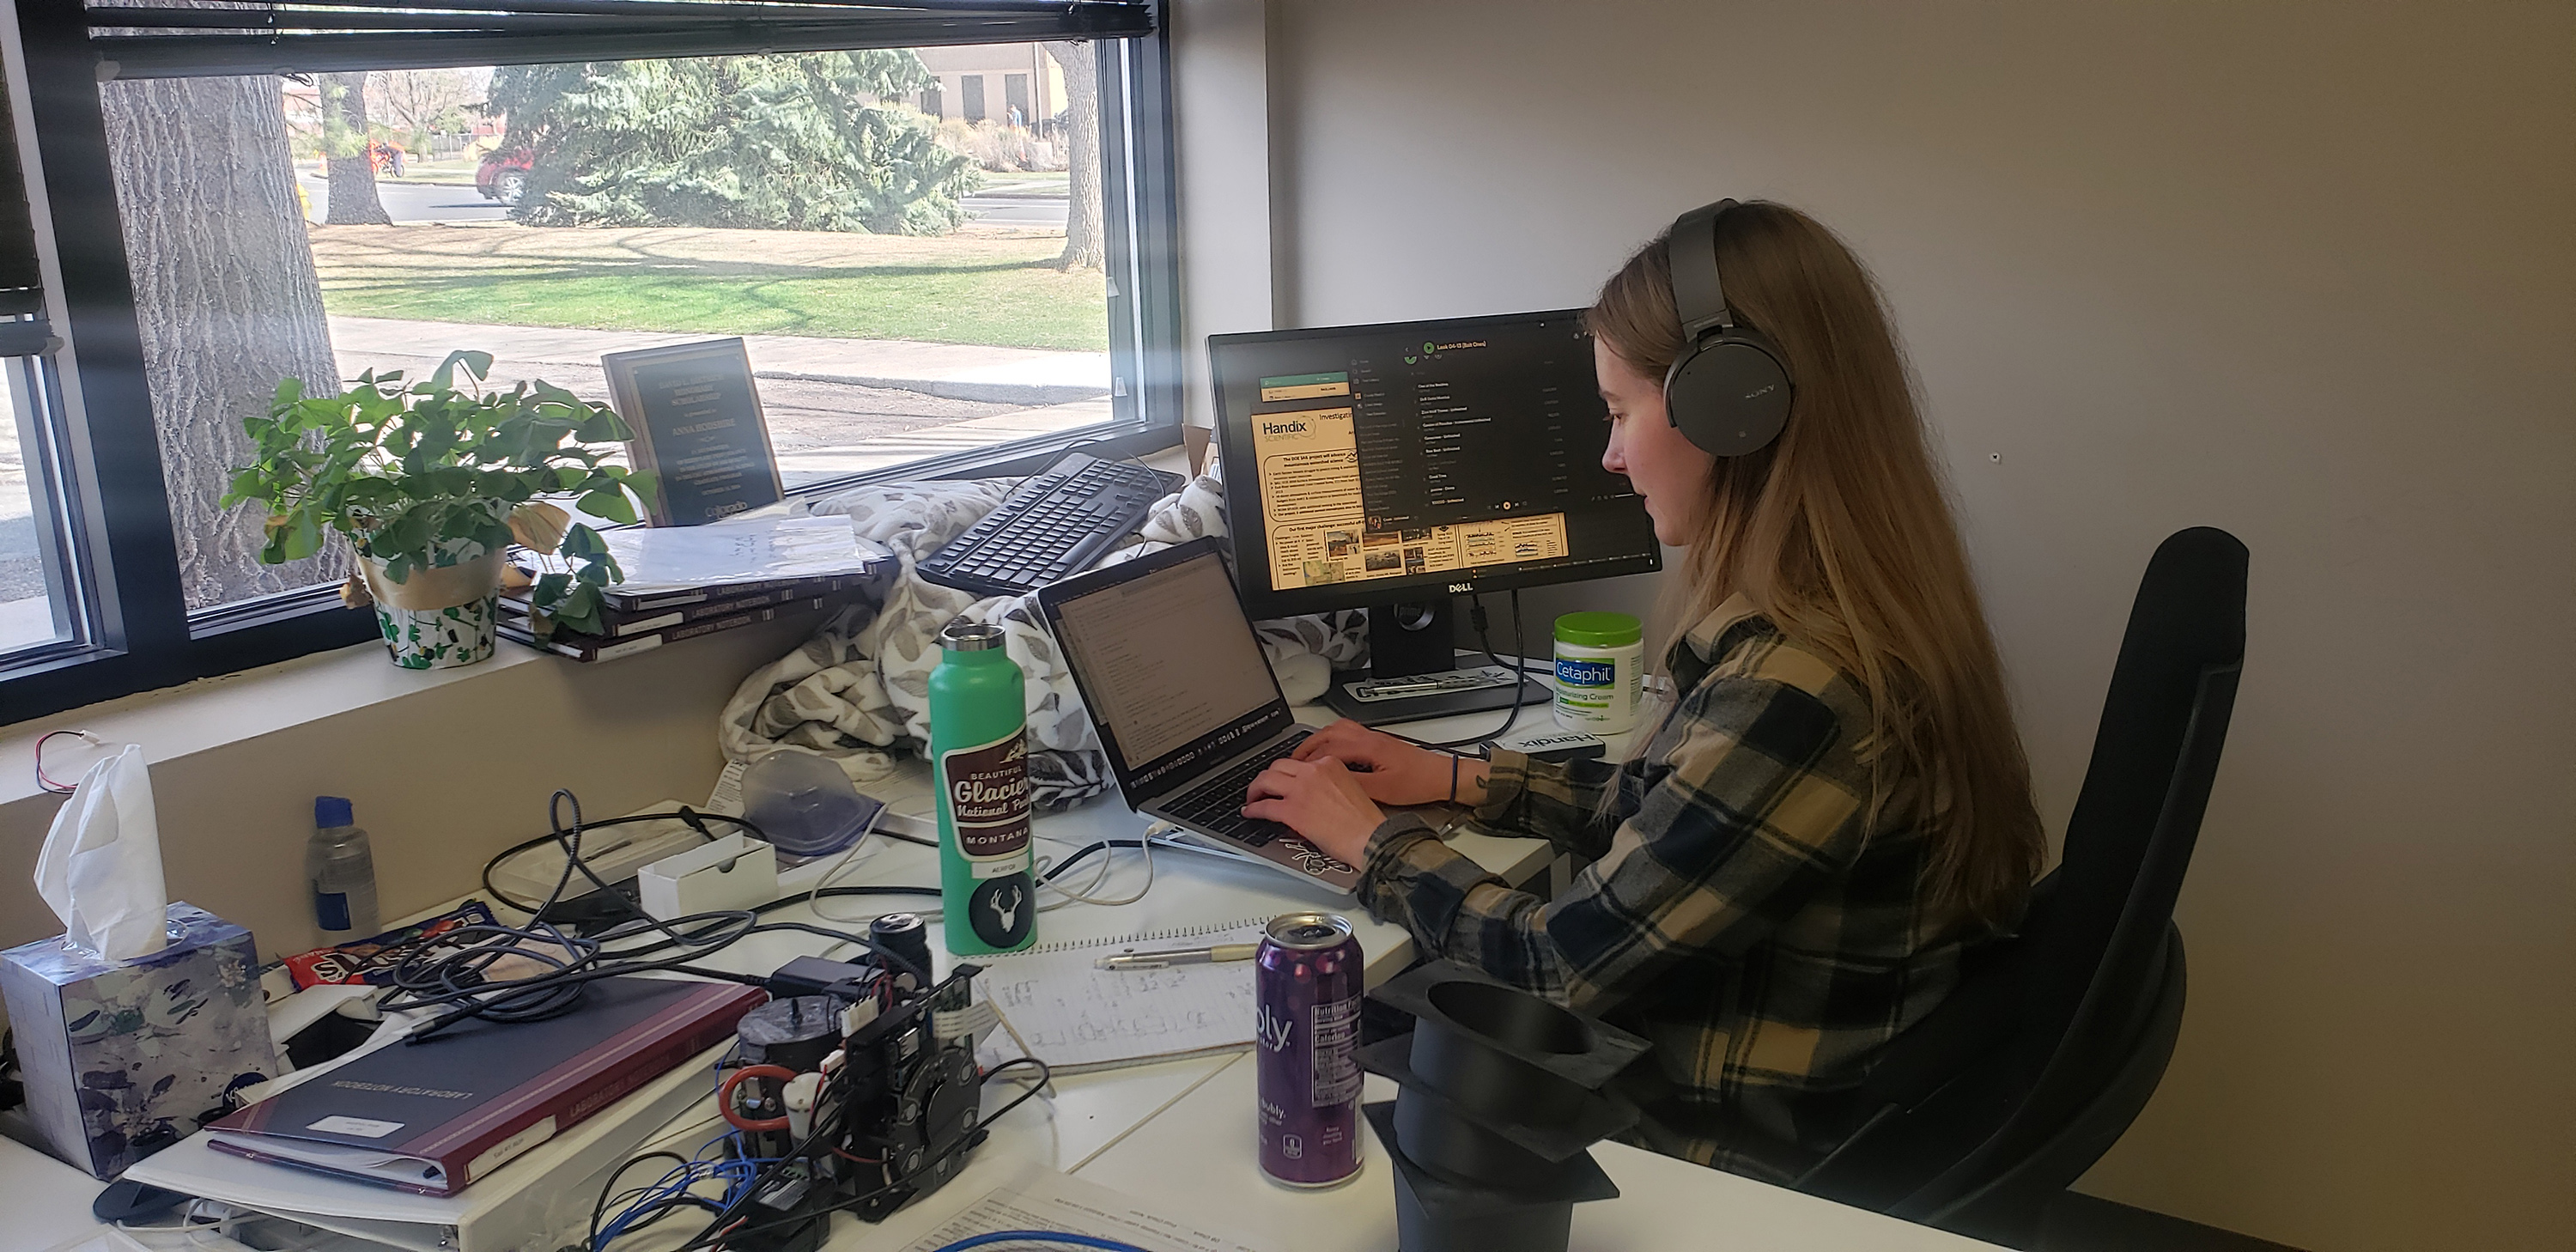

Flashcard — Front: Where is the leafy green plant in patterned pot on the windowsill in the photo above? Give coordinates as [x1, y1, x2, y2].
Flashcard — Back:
[224, 353, 652, 670]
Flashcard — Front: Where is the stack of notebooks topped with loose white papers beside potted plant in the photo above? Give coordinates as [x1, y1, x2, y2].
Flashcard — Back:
[500, 518, 894, 662]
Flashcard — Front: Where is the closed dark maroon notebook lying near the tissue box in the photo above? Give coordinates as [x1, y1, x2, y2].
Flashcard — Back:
[206, 979, 768, 1195]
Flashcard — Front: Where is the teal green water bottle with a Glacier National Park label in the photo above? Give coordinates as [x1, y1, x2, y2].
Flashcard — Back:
[930, 621, 1038, 956]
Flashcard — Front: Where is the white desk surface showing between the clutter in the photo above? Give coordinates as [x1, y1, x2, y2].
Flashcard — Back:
[0, 714, 1989, 1252]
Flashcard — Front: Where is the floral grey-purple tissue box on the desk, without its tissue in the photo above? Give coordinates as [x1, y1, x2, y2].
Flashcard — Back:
[0, 902, 278, 1177]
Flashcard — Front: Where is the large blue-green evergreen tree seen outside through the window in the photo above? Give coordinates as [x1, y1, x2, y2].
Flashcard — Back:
[489, 49, 981, 234]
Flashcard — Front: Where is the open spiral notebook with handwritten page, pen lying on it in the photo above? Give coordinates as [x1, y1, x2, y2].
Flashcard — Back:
[979, 917, 1267, 1074]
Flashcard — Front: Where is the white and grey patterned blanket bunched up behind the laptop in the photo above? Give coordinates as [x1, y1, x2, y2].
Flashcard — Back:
[716, 464, 1368, 809]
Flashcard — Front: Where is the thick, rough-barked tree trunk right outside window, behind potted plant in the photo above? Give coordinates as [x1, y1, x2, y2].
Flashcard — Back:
[100, 75, 350, 608]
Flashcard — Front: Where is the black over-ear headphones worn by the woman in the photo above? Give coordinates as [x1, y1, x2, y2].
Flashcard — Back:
[1664, 201, 1793, 456]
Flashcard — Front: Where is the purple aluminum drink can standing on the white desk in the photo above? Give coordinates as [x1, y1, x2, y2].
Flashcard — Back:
[1255, 912, 1368, 1188]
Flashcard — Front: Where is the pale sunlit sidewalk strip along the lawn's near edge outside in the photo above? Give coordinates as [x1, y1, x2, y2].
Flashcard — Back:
[330, 317, 1110, 404]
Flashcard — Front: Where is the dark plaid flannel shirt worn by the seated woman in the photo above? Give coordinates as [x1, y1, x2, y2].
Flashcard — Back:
[1360, 598, 1973, 1177]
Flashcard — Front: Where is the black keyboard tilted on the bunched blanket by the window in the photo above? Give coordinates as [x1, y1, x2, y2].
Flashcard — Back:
[920, 453, 1182, 595]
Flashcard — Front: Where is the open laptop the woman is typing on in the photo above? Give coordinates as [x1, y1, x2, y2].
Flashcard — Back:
[1038, 538, 1360, 894]
